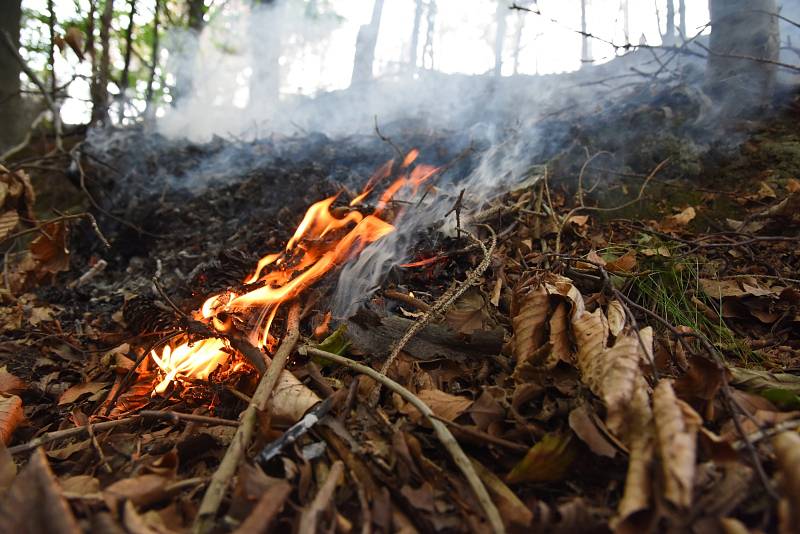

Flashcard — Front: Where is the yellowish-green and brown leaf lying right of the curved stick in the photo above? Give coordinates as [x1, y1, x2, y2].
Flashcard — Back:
[506, 432, 578, 484]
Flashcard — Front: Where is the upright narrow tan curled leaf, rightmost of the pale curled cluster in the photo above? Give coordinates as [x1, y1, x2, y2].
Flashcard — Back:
[653, 379, 703, 508]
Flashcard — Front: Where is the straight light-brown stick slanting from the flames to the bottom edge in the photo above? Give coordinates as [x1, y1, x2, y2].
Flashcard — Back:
[192, 301, 300, 534]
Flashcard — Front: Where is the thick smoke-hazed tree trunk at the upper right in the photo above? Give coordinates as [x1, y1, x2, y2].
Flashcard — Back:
[706, 0, 780, 117]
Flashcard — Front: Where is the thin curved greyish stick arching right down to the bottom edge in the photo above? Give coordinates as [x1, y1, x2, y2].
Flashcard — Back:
[299, 346, 505, 533]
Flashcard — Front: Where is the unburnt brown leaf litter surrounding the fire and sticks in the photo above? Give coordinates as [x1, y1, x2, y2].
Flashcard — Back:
[0, 135, 800, 532]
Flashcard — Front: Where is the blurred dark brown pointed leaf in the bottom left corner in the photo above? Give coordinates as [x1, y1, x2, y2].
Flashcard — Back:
[0, 449, 81, 534]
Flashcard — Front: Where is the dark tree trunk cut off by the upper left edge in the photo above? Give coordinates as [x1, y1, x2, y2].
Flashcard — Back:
[0, 0, 25, 152]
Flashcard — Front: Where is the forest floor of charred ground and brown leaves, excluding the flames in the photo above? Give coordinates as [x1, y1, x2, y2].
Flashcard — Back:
[0, 85, 800, 533]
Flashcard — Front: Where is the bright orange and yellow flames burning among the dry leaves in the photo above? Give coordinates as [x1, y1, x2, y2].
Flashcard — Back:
[151, 150, 439, 393]
